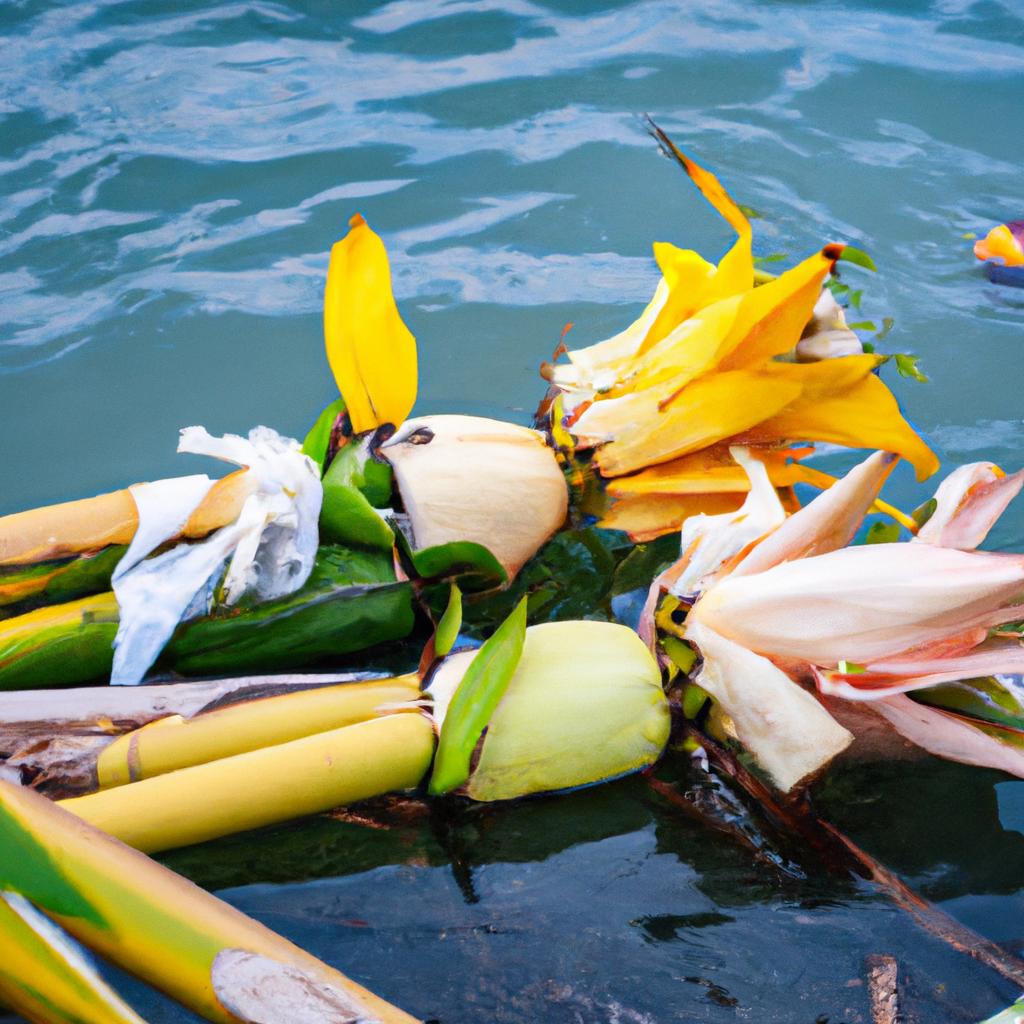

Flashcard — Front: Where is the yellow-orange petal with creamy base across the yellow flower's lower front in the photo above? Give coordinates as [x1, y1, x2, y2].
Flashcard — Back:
[574, 370, 801, 476]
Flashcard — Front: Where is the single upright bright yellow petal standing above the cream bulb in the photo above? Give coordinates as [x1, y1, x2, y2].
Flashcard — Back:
[324, 214, 417, 433]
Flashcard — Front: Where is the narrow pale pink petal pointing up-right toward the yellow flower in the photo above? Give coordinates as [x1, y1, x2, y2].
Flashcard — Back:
[731, 452, 898, 577]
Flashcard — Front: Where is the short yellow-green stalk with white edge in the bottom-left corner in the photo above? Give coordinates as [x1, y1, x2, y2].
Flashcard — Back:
[0, 892, 144, 1024]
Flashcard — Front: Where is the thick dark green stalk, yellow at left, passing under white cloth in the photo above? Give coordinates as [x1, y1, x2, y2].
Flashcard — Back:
[0, 546, 414, 690]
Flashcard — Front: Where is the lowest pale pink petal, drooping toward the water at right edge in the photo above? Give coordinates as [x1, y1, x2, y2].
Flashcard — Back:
[871, 695, 1024, 778]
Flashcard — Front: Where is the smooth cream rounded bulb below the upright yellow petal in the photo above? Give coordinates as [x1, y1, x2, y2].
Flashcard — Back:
[382, 416, 568, 580]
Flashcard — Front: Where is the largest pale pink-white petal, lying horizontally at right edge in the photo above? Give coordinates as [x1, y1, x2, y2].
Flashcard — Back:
[690, 544, 1024, 667]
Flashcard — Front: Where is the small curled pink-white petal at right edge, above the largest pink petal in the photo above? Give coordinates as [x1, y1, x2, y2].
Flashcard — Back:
[916, 462, 1024, 551]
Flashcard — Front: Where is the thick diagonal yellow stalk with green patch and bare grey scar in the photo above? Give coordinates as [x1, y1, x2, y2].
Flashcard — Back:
[0, 778, 417, 1024]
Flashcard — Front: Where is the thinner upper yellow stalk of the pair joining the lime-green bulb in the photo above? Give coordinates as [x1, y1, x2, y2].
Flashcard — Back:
[96, 675, 420, 790]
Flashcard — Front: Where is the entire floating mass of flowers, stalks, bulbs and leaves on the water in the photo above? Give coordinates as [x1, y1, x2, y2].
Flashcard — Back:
[0, 125, 1024, 1024]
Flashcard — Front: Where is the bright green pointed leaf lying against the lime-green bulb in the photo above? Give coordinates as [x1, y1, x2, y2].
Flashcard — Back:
[429, 598, 526, 796]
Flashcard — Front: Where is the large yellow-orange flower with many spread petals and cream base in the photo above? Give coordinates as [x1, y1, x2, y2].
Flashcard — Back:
[548, 136, 938, 540]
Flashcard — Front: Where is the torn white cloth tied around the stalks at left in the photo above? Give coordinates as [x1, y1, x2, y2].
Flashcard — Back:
[111, 427, 324, 686]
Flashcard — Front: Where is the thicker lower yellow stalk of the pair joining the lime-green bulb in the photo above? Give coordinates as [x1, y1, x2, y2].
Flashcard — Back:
[61, 713, 434, 853]
